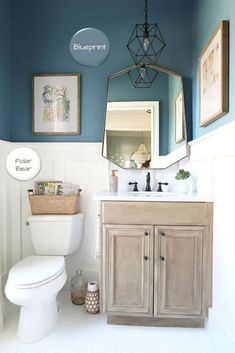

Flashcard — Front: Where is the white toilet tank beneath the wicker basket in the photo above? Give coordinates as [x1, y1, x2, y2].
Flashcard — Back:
[27, 213, 84, 256]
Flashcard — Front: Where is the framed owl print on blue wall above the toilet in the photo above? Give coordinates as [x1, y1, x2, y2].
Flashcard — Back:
[32, 74, 80, 135]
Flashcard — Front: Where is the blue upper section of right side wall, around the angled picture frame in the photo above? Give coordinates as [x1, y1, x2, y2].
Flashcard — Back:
[192, 0, 235, 138]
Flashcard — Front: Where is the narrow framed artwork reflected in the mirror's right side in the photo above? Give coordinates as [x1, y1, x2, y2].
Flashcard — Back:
[175, 92, 184, 143]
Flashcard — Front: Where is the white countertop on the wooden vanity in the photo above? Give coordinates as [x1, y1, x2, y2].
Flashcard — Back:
[93, 191, 213, 202]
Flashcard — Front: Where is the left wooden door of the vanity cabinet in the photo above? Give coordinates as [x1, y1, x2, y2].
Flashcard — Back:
[104, 225, 153, 315]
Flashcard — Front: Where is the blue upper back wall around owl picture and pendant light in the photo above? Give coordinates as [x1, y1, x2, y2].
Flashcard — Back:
[11, 0, 192, 142]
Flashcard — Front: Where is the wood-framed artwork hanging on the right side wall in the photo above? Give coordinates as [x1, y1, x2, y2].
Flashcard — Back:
[199, 21, 229, 126]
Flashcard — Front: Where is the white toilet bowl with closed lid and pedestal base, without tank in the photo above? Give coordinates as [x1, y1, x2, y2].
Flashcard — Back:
[5, 256, 67, 343]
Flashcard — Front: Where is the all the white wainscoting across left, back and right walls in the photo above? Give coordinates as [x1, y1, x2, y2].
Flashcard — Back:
[0, 122, 235, 353]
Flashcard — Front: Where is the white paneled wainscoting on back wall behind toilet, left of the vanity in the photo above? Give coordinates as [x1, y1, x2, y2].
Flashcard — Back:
[5, 143, 108, 289]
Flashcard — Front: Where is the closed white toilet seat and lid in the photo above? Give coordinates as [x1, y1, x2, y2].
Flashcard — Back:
[8, 255, 65, 289]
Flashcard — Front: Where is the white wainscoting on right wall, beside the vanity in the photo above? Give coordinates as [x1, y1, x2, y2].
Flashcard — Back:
[180, 122, 235, 353]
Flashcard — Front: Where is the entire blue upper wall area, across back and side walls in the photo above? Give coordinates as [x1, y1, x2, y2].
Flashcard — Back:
[4, 0, 235, 141]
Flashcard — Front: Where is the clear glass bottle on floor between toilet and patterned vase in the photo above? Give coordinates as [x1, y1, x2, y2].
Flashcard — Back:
[71, 270, 87, 305]
